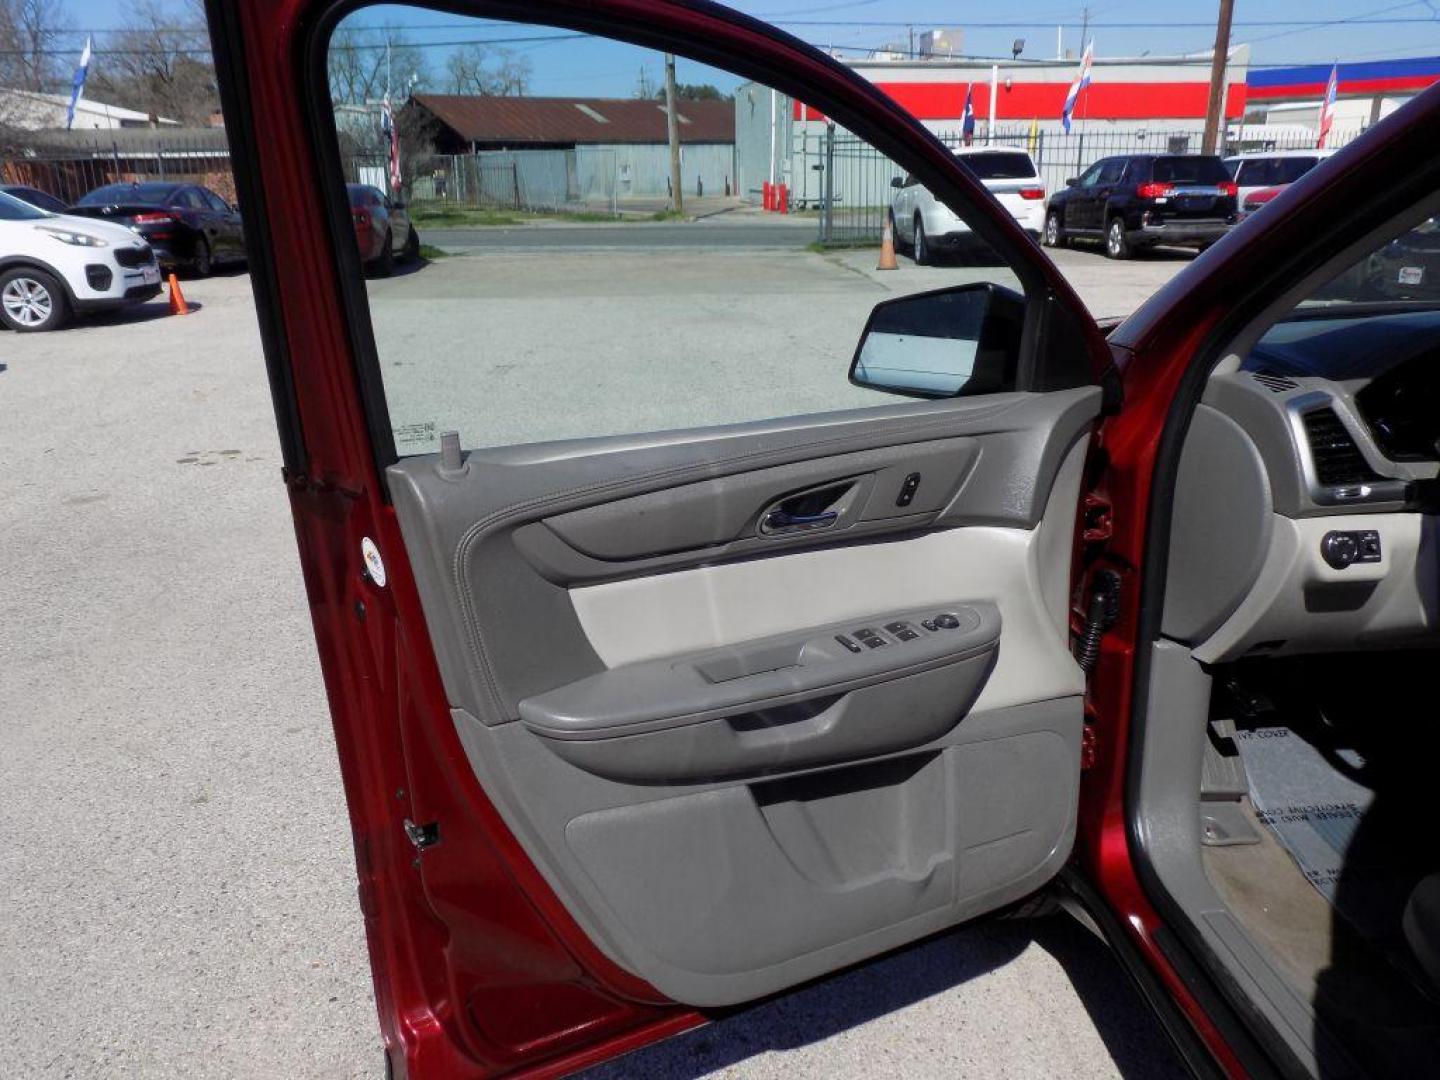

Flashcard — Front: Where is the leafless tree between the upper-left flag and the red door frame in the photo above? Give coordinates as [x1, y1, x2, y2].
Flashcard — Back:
[86, 0, 220, 127]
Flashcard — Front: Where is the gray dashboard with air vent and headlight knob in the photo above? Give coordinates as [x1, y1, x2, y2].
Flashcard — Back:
[1164, 305, 1440, 662]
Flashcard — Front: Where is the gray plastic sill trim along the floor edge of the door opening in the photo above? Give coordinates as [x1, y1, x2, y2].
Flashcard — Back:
[1135, 639, 1359, 1073]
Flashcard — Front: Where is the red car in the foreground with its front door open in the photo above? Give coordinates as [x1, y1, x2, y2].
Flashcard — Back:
[207, 0, 1440, 1079]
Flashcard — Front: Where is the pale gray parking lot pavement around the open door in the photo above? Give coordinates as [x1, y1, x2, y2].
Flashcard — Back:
[0, 230, 1185, 1077]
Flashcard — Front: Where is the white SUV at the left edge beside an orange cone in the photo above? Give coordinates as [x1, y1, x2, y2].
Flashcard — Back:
[0, 192, 160, 331]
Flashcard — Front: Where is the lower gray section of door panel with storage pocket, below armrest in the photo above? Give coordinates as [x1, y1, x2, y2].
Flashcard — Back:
[454, 697, 1083, 1007]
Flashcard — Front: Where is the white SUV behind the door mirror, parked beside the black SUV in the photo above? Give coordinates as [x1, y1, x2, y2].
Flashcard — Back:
[890, 147, 1045, 265]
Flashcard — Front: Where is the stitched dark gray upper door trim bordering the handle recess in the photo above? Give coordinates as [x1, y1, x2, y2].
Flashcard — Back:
[387, 387, 1100, 723]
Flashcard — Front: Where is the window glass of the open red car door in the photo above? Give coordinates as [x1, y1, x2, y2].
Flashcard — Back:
[317, 6, 1038, 456]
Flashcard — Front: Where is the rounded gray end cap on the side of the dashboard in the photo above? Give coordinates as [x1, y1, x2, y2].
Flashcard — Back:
[1164, 405, 1272, 644]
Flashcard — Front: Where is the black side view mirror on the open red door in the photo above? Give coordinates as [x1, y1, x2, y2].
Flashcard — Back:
[850, 281, 1025, 397]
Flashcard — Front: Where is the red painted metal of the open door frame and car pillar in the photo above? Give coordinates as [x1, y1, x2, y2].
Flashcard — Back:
[200, 0, 1440, 1077]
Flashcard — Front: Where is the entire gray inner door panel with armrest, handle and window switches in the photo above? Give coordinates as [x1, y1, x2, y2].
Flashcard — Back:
[389, 387, 1099, 1005]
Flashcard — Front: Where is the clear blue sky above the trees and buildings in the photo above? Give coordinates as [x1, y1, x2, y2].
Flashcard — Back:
[65, 0, 1440, 96]
